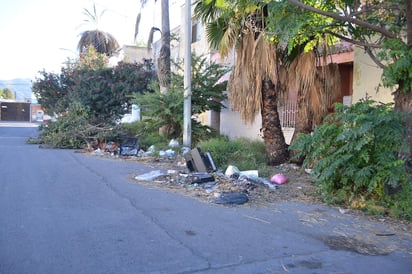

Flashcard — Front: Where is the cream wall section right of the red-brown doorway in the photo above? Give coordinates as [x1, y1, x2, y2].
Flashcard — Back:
[352, 47, 393, 103]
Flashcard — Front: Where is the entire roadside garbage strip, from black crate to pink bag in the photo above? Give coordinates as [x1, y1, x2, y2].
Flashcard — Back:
[88, 138, 288, 205]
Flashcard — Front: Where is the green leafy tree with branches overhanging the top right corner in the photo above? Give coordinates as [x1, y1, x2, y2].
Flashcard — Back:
[271, 0, 412, 157]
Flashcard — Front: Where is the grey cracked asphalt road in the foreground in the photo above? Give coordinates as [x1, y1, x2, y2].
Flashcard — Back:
[0, 123, 412, 274]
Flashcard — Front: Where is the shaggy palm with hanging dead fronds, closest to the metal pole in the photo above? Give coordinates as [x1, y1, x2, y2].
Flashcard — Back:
[195, 0, 288, 165]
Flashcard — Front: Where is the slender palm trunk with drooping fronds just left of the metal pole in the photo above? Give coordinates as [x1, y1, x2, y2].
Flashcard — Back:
[135, 0, 171, 94]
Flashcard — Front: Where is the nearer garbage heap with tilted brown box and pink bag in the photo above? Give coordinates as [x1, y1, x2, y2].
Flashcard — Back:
[134, 148, 287, 205]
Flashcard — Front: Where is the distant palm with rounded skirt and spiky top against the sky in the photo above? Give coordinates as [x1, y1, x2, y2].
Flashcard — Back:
[77, 4, 119, 56]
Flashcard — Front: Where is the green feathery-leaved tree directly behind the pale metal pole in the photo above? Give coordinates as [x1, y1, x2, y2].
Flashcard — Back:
[134, 55, 226, 143]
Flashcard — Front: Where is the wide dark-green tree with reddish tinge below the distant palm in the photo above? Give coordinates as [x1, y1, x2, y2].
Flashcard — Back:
[32, 53, 155, 121]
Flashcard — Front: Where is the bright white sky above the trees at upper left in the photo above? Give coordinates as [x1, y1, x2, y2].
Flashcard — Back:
[0, 0, 180, 80]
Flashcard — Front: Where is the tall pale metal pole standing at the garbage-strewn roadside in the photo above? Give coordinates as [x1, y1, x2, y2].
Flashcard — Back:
[183, 0, 192, 148]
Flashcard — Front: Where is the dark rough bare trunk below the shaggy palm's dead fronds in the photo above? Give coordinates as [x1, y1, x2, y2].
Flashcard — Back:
[261, 80, 289, 165]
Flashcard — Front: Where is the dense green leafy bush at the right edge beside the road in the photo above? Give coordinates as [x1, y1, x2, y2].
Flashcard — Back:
[290, 100, 410, 219]
